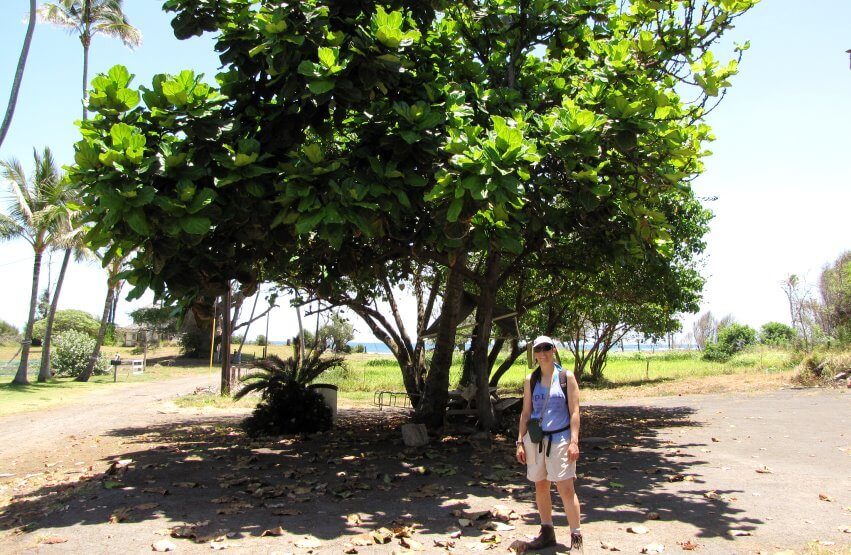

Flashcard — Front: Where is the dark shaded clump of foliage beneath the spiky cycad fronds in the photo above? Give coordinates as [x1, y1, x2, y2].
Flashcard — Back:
[243, 381, 332, 437]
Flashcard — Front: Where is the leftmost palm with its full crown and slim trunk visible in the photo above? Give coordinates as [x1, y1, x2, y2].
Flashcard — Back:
[0, 148, 68, 385]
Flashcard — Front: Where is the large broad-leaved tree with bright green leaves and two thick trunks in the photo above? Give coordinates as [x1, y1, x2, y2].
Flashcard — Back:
[74, 0, 753, 427]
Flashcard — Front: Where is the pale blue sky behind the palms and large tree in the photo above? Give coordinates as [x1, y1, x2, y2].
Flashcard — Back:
[0, 0, 851, 339]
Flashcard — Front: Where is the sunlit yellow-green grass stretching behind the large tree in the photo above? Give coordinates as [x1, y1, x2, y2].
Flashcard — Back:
[0, 345, 798, 415]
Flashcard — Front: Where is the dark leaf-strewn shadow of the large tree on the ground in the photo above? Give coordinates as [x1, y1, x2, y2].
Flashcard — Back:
[0, 406, 759, 547]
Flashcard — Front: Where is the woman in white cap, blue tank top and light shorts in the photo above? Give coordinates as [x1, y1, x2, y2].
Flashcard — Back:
[516, 335, 582, 551]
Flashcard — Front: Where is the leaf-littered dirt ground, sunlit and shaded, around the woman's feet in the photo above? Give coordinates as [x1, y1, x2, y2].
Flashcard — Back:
[0, 378, 851, 554]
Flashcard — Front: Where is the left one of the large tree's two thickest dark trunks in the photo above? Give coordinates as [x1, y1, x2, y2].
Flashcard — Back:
[416, 250, 467, 429]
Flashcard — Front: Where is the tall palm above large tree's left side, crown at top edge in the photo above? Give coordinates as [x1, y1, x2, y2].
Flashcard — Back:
[38, 0, 142, 120]
